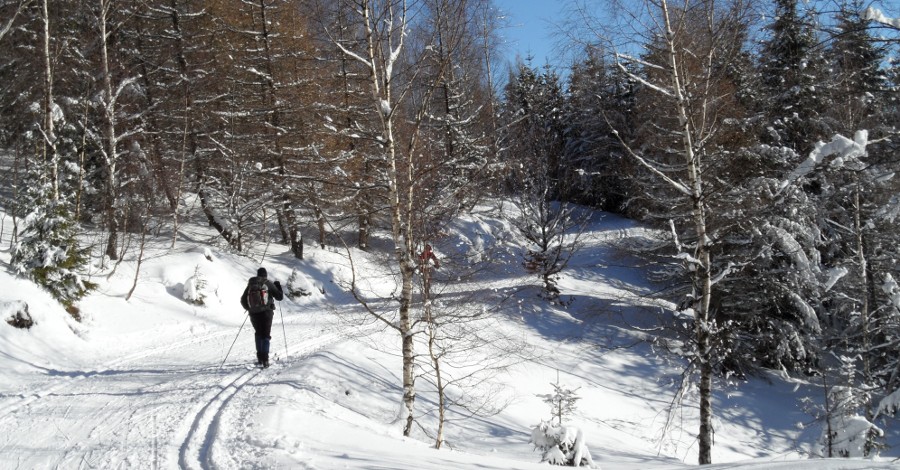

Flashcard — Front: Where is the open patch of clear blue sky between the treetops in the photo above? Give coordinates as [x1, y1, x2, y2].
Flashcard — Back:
[495, 0, 568, 67]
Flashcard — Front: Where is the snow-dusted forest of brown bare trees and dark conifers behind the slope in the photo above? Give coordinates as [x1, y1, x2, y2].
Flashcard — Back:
[0, 0, 900, 463]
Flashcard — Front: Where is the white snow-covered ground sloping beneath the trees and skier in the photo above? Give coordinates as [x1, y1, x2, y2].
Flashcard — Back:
[0, 209, 900, 470]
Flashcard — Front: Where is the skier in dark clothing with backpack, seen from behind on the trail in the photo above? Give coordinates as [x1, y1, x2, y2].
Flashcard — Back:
[241, 268, 284, 368]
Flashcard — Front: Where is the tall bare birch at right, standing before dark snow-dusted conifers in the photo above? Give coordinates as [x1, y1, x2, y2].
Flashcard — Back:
[588, 0, 747, 464]
